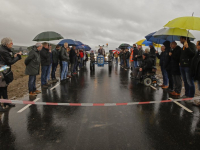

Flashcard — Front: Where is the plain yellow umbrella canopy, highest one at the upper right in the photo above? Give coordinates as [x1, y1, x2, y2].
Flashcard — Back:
[164, 16, 200, 31]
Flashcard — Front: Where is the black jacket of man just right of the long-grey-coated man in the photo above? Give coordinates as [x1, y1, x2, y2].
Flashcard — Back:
[40, 47, 51, 66]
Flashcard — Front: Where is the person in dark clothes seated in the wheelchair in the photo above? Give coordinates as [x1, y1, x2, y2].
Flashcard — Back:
[133, 53, 154, 80]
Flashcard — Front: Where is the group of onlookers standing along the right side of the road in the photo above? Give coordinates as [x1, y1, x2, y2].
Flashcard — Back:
[115, 36, 200, 106]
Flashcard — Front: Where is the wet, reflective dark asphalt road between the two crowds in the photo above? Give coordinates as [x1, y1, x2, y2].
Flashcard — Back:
[0, 63, 200, 150]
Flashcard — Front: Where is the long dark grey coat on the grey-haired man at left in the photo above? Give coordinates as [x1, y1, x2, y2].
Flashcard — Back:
[24, 46, 40, 76]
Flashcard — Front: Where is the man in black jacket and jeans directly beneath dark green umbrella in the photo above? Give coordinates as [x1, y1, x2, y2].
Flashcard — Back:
[40, 42, 51, 88]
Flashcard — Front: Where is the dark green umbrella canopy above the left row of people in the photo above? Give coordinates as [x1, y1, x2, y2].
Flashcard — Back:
[33, 31, 63, 41]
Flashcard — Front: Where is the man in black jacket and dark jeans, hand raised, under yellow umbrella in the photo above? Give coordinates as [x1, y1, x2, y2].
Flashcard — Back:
[180, 37, 196, 98]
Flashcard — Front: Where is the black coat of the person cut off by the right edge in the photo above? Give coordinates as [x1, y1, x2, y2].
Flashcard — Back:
[190, 51, 200, 81]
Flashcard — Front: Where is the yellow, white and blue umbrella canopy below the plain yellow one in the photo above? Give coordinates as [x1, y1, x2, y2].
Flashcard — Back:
[153, 28, 195, 42]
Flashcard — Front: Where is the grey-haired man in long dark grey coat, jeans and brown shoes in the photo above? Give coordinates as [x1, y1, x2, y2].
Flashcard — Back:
[24, 43, 42, 96]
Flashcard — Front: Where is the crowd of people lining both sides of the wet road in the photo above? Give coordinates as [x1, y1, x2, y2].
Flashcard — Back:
[0, 37, 200, 111]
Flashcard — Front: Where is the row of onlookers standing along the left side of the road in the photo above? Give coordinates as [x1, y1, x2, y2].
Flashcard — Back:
[0, 38, 88, 112]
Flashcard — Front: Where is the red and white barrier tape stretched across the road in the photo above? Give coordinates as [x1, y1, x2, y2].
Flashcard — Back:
[0, 97, 200, 107]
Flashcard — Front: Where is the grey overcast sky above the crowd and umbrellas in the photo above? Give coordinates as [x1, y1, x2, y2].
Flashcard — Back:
[0, 0, 200, 49]
